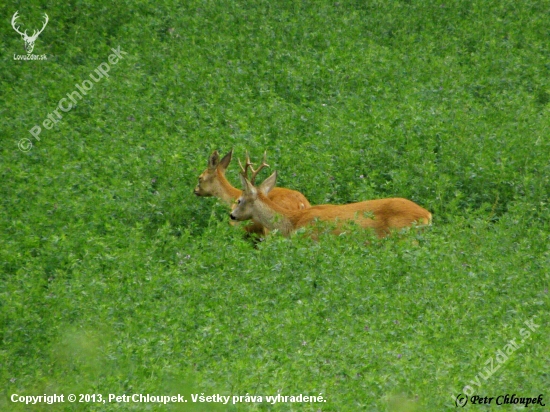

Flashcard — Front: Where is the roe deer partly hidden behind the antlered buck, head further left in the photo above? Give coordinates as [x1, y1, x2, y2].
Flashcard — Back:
[194, 149, 311, 234]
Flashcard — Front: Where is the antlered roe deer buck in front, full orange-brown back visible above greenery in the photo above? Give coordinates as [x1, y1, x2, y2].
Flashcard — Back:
[231, 165, 432, 237]
